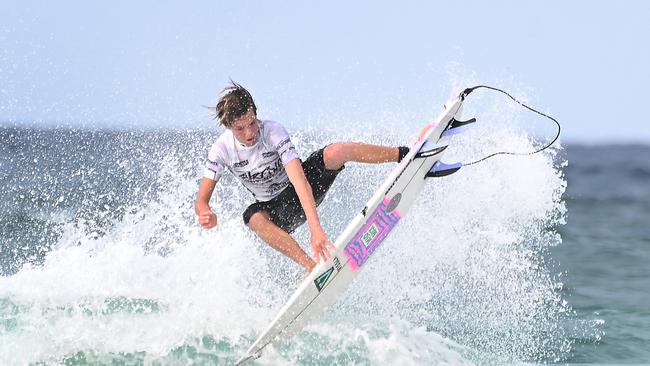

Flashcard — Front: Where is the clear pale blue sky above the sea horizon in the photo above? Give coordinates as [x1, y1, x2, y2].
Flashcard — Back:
[0, 0, 650, 143]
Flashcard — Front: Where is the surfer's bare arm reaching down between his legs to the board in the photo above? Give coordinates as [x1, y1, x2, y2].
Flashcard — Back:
[284, 159, 334, 261]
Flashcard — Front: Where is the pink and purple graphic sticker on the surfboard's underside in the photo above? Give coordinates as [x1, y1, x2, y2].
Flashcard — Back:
[345, 197, 400, 271]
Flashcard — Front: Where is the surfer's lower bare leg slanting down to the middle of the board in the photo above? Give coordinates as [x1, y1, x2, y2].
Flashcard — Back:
[248, 211, 316, 272]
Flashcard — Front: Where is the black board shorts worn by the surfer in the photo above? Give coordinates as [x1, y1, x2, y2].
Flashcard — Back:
[243, 148, 345, 233]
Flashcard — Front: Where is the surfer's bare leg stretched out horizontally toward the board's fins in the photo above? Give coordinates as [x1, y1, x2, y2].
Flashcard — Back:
[323, 142, 399, 170]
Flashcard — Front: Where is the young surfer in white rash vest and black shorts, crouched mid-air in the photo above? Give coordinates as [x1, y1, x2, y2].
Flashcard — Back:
[195, 82, 408, 272]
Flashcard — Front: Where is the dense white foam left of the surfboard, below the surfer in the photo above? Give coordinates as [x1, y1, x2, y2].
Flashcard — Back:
[0, 153, 286, 364]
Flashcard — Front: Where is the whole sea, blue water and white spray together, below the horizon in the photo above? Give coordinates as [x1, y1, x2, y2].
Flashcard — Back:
[0, 117, 650, 365]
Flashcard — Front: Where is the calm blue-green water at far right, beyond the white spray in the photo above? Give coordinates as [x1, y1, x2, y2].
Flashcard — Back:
[551, 145, 650, 363]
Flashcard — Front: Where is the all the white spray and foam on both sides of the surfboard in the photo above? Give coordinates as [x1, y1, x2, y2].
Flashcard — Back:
[0, 76, 570, 365]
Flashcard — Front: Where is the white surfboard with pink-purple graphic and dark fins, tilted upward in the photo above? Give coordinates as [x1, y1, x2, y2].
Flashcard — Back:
[236, 94, 475, 365]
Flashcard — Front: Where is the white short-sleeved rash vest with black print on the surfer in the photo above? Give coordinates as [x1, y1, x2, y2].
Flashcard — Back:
[203, 120, 298, 201]
